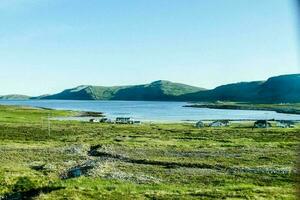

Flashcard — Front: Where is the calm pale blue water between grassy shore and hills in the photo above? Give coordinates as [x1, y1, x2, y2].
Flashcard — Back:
[0, 100, 300, 122]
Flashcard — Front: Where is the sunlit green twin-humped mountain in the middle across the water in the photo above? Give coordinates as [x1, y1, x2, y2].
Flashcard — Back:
[41, 80, 204, 101]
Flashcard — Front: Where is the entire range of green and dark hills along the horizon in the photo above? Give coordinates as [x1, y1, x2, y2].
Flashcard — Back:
[0, 74, 300, 103]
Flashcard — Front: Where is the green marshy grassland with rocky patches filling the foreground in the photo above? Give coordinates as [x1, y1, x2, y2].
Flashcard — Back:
[0, 106, 300, 199]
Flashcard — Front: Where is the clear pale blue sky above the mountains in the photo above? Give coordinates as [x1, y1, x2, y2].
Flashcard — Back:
[0, 0, 299, 95]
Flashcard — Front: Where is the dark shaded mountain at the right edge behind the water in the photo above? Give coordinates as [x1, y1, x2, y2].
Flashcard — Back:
[180, 74, 300, 103]
